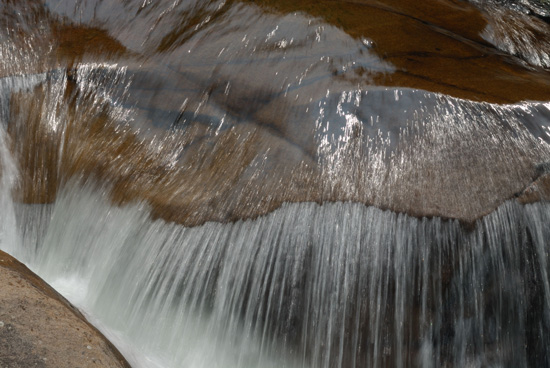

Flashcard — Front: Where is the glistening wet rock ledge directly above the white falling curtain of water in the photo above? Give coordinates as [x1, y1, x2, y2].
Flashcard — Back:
[4, 65, 550, 225]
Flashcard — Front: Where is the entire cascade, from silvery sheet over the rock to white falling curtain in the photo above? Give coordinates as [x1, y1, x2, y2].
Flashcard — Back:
[0, 0, 550, 368]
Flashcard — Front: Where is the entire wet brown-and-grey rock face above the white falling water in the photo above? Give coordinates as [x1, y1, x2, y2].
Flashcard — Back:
[0, 0, 550, 226]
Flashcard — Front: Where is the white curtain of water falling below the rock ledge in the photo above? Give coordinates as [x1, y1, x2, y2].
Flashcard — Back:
[1, 185, 550, 367]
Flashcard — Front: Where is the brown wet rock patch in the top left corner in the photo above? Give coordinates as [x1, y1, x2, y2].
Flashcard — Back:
[0, 0, 132, 77]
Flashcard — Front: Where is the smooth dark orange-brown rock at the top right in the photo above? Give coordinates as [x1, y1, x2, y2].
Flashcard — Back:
[238, 0, 550, 103]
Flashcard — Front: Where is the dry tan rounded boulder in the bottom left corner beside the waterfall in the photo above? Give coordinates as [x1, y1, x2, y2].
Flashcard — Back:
[0, 251, 130, 368]
